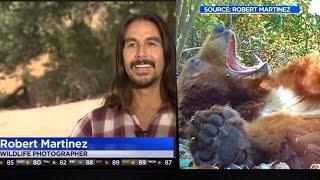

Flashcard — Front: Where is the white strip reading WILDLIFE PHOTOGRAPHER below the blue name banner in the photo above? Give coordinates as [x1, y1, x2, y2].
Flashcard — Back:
[0, 150, 175, 158]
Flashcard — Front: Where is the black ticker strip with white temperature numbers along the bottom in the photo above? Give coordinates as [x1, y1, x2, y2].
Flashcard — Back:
[0, 159, 174, 167]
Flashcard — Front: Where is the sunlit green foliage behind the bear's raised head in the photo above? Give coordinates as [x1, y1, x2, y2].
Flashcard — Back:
[180, 0, 320, 69]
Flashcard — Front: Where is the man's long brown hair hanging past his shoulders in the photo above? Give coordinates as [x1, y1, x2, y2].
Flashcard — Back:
[103, 11, 177, 109]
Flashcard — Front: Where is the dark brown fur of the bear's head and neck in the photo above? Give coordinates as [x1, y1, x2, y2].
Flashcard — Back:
[178, 27, 270, 138]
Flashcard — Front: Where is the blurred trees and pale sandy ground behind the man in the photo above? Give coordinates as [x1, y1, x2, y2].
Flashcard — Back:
[0, 2, 176, 137]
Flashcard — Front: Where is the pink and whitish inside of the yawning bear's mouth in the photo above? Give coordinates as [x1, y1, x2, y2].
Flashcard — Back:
[226, 36, 266, 74]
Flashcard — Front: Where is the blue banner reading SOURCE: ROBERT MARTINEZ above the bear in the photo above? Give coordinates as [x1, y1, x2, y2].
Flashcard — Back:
[200, 5, 300, 14]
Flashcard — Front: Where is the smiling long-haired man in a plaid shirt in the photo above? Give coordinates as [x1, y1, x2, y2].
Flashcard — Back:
[70, 12, 177, 137]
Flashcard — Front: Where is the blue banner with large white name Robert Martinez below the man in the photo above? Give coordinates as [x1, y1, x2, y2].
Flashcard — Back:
[0, 138, 174, 150]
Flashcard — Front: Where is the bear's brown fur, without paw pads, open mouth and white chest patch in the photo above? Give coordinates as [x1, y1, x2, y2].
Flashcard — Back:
[178, 24, 320, 168]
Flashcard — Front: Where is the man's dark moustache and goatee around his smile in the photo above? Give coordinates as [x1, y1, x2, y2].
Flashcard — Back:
[129, 59, 158, 89]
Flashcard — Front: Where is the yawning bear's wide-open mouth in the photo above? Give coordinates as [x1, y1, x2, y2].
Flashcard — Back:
[226, 35, 268, 76]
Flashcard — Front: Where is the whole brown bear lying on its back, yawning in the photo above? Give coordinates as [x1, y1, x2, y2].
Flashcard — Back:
[178, 26, 320, 168]
